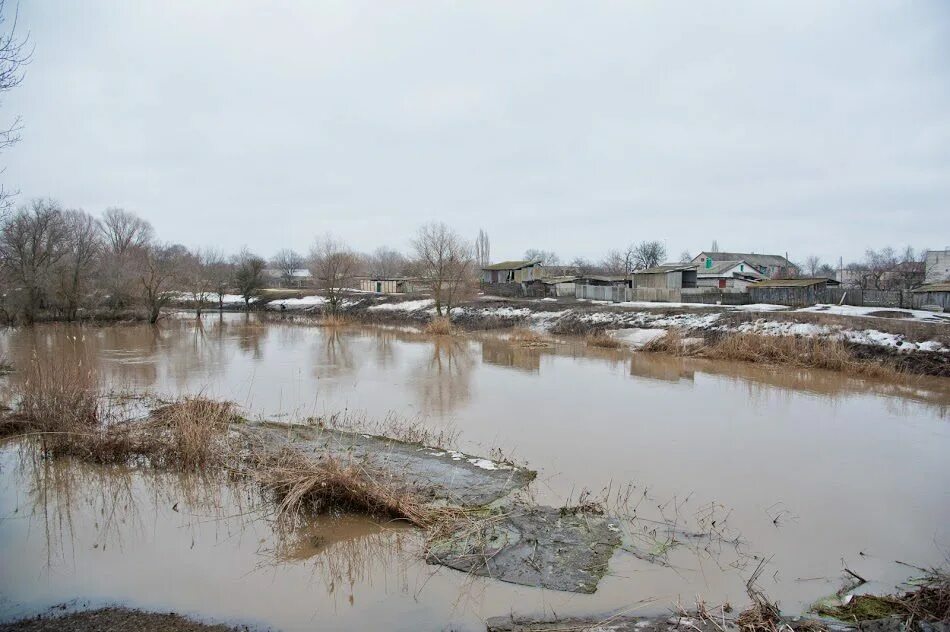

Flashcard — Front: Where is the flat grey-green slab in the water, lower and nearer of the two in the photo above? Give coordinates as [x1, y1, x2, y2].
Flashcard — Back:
[427, 506, 620, 593]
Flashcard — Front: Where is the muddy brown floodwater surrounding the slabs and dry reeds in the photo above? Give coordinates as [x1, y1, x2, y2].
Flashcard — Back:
[0, 314, 950, 630]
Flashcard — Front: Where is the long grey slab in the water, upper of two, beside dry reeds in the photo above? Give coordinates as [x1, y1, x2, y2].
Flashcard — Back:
[237, 423, 536, 507]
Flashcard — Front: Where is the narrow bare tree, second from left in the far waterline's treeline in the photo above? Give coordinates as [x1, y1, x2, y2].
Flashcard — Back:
[56, 210, 103, 320]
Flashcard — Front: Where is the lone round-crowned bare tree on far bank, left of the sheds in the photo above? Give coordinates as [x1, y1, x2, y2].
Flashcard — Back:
[412, 222, 476, 316]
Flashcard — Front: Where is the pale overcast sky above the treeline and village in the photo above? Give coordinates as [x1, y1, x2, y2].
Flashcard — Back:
[0, 0, 950, 262]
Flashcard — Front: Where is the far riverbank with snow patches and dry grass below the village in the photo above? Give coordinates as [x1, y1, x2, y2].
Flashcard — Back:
[210, 294, 950, 377]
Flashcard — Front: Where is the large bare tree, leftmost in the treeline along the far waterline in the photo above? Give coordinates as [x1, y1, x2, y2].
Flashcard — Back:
[0, 199, 66, 324]
